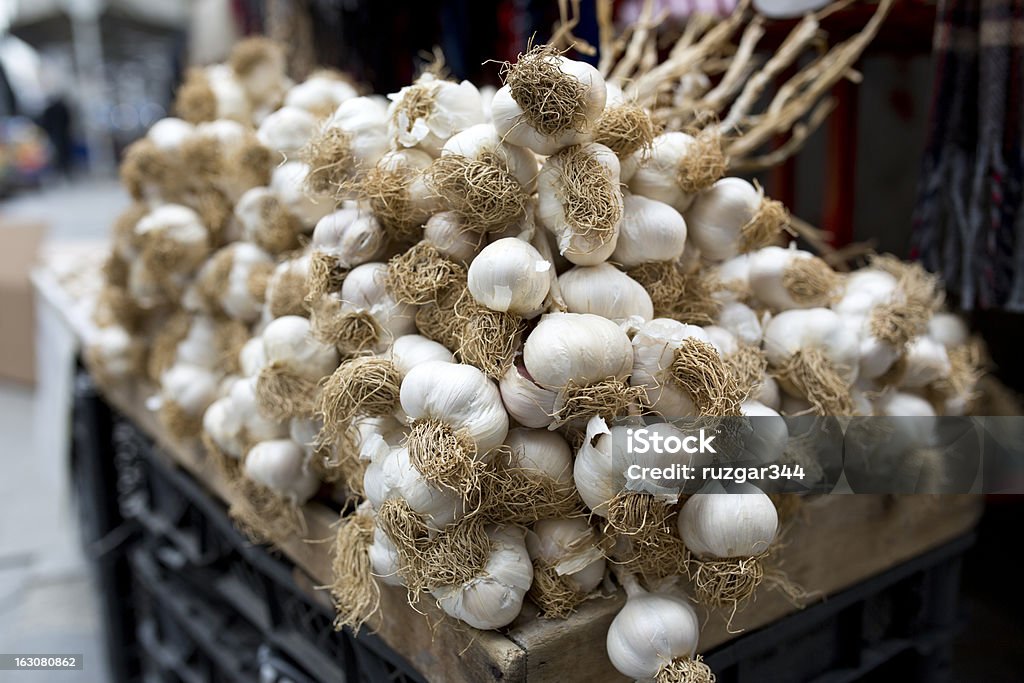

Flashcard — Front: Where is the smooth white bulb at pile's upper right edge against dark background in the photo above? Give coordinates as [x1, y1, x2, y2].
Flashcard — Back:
[684, 178, 763, 261]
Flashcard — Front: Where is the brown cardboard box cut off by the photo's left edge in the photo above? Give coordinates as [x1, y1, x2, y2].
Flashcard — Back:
[0, 222, 46, 384]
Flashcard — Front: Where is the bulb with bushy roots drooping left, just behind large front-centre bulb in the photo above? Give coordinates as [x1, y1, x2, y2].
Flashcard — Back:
[318, 335, 455, 442]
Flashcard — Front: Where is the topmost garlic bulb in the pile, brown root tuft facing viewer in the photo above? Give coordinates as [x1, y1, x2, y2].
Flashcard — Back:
[490, 53, 607, 155]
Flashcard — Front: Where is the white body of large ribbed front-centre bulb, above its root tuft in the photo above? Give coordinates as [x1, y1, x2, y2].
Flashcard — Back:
[399, 360, 509, 458]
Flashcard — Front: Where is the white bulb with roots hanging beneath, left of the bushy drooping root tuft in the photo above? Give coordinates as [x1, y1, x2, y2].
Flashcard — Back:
[256, 315, 338, 420]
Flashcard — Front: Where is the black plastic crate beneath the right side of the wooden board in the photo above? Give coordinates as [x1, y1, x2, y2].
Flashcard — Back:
[706, 536, 973, 683]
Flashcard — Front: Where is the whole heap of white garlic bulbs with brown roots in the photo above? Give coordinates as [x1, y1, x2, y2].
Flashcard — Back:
[88, 40, 976, 680]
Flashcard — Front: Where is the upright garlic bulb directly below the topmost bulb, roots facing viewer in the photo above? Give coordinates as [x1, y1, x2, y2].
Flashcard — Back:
[537, 142, 624, 265]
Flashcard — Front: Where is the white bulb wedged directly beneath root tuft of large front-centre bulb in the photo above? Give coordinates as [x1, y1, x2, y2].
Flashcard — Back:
[361, 436, 464, 530]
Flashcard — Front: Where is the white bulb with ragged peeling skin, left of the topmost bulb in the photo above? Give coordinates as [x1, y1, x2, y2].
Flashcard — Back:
[388, 72, 483, 157]
